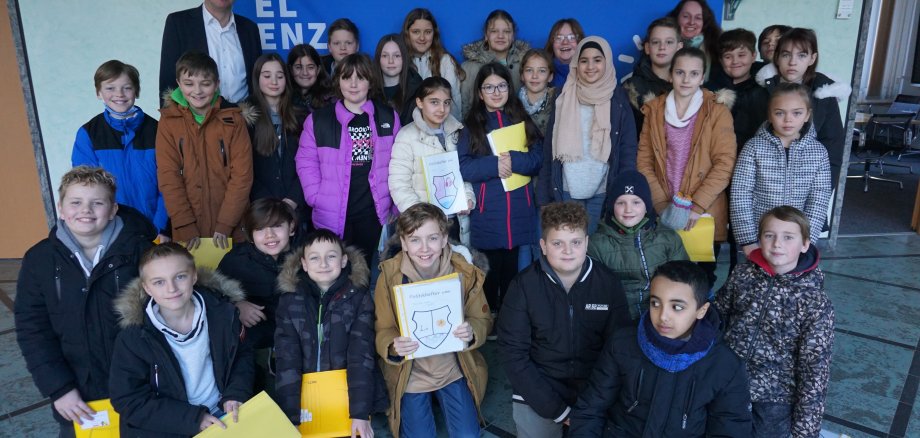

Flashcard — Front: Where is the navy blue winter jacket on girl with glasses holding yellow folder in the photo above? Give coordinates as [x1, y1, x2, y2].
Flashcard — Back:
[457, 111, 543, 250]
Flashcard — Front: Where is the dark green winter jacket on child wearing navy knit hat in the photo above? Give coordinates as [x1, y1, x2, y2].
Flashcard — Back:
[588, 221, 689, 321]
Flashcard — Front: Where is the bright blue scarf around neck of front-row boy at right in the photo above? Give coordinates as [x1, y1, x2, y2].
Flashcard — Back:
[637, 309, 719, 373]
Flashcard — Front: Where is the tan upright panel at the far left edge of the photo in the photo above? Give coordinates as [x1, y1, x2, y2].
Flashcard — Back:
[0, 2, 48, 258]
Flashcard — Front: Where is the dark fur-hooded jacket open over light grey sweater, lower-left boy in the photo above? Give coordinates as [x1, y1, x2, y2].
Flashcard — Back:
[109, 271, 255, 438]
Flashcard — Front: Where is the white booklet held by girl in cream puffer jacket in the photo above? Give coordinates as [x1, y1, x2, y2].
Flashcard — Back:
[419, 151, 467, 215]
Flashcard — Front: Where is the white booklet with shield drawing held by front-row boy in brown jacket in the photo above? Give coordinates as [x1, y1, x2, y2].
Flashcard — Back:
[393, 273, 466, 359]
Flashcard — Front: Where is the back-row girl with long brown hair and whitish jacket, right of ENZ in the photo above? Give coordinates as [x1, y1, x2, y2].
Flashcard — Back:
[402, 8, 466, 120]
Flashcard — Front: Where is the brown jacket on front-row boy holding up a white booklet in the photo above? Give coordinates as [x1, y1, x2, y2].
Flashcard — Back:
[374, 251, 492, 438]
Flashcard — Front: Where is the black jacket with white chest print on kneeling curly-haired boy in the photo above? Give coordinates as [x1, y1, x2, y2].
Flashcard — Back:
[496, 257, 632, 422]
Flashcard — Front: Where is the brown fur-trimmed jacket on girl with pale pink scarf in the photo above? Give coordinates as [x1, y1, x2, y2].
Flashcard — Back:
[636, 89, 738, 242]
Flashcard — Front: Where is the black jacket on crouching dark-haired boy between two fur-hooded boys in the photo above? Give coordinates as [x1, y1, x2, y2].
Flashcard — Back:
[217, 238, 294, 348]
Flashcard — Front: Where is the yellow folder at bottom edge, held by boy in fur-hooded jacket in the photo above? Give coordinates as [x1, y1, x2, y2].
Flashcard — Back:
[195, 391, 300, 438]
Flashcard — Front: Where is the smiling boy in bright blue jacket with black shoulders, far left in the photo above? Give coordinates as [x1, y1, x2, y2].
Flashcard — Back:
[70, 59, 169, 242]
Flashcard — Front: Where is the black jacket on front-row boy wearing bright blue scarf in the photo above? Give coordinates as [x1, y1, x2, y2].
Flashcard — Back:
[569, 309, 751, 438]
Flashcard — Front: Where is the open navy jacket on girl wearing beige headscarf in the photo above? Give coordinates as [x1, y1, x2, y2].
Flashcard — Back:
[537, 87, 639, 207]
